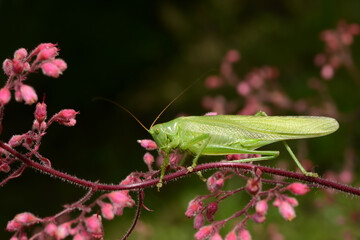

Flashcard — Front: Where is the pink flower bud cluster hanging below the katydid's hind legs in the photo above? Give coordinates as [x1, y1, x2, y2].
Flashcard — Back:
[185, 170, 309, 240]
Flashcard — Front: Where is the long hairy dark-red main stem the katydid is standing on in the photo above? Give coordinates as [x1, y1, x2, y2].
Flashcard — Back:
[0, 141, 360, 196]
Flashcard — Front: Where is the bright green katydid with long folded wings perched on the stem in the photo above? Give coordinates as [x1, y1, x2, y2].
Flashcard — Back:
[148, 111, 339, 188]
